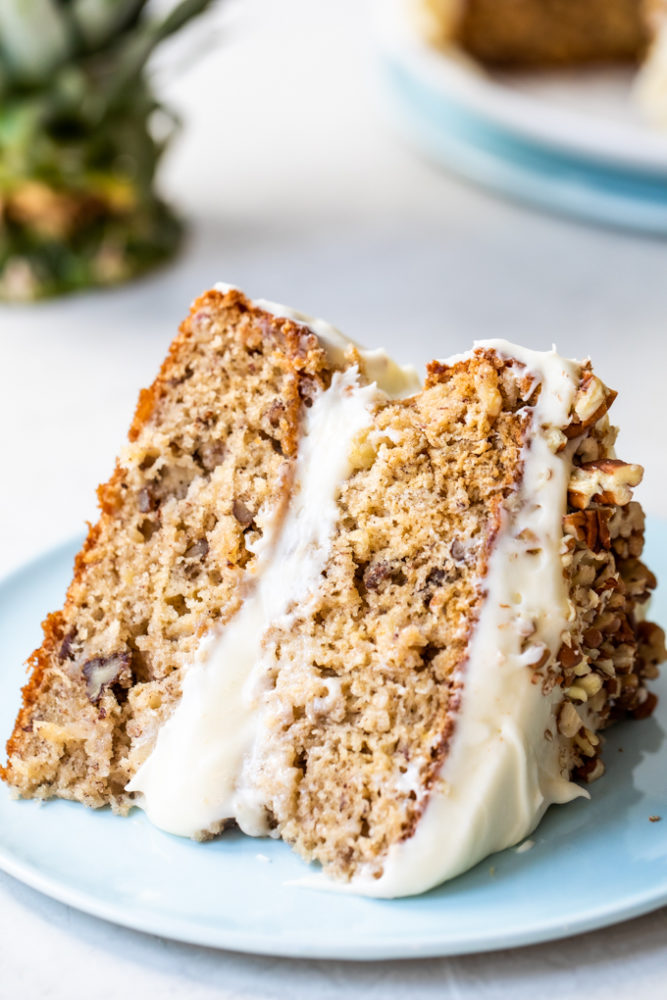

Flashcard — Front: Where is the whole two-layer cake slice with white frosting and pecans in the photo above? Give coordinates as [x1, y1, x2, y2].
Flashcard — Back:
[3, 287, 664, 896]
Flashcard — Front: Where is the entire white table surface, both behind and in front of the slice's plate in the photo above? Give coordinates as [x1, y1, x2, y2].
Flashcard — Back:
[0, 0, 667, 1000]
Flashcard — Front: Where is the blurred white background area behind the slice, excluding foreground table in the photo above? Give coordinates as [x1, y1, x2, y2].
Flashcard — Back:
[0, 0, 667, 572]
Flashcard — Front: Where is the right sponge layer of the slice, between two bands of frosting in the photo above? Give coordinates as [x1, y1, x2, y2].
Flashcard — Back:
[251, 355, 534, 877]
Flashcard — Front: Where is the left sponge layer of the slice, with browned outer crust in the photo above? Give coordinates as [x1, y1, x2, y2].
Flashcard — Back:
[3, 289, 366, 809]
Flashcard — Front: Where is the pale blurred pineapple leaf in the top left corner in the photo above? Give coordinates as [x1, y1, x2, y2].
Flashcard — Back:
[0, 0, 73, 83]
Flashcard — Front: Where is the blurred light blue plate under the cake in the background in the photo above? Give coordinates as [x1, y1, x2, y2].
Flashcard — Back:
[378, 0, 667, 236]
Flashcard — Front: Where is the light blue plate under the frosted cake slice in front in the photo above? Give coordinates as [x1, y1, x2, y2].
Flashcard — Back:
[0, 522, 667, 959]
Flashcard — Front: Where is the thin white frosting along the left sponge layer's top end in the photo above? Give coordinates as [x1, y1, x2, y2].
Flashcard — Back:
[215, 281, 420, 399]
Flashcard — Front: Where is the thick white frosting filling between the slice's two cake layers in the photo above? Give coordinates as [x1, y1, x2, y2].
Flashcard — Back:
[127, 367, 386, 836]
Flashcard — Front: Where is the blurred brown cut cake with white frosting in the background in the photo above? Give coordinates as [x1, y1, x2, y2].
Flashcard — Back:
[420, 0, 667, 127]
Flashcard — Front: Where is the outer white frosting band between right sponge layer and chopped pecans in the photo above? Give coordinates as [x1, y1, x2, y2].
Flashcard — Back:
[301, 340, 588, 897]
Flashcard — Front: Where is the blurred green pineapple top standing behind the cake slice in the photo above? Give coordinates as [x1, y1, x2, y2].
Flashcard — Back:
[0, 0, 211, 300]
